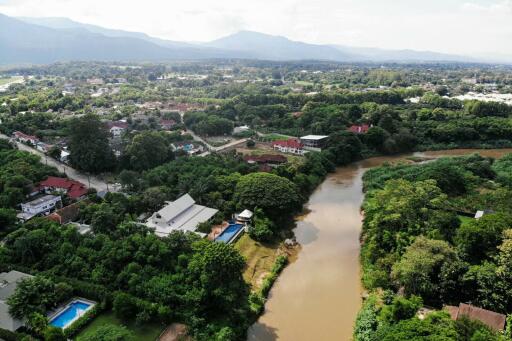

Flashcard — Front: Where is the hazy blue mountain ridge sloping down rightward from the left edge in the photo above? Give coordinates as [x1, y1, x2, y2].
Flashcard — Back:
[0, 14, 240, 64]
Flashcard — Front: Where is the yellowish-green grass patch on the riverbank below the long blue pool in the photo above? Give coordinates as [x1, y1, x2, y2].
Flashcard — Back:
[235, 234, 279, 291]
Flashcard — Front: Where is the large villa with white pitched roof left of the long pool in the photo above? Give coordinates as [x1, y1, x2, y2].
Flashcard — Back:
[146, 194, 218, 237]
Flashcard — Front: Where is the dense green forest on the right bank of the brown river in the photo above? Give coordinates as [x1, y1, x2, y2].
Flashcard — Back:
[354, 154, 512, 340]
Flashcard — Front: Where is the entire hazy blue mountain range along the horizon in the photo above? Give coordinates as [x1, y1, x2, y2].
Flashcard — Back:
[0, 14, 492, 64]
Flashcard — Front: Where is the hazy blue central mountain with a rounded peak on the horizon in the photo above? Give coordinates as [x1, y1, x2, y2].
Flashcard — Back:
[205, 31, 359, 61]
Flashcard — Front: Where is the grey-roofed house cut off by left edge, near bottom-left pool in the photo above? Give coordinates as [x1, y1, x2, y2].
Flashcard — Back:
[0, 270, 32, 332]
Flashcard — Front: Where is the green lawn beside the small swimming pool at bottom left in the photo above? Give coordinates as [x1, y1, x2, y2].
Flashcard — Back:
[77, 312, 165, 341]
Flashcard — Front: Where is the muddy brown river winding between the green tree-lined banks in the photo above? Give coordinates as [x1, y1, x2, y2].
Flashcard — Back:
[248, 149, 512, 341]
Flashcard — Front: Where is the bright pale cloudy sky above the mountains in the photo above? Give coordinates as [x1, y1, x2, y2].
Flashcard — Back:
[0, 0, 512, 57]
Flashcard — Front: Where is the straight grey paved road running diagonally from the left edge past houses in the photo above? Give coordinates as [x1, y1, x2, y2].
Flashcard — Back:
[0, 134, 115, 192]
